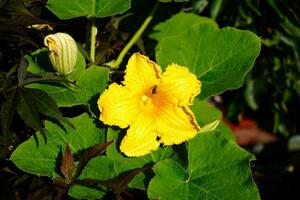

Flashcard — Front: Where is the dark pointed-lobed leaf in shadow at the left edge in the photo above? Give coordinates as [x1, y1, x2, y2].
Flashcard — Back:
[0, 57, 72, 146]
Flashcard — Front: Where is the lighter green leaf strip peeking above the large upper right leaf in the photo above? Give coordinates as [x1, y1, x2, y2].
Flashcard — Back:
[149, 12, 218, 41]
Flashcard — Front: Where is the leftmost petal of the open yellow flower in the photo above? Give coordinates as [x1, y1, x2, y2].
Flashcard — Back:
[98, 83, 140, 128]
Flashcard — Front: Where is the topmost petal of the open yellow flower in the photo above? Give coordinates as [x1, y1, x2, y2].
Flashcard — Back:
[123, 53, 161, 91]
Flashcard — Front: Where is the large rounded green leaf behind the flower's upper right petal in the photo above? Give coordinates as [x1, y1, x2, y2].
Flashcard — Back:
[156, 23, 260, 99]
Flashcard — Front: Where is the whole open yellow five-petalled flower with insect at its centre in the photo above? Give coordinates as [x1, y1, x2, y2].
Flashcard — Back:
[98, 53, 201, 157]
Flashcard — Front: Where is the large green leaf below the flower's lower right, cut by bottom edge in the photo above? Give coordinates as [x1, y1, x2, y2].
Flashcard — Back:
[148, 131, 260, 200]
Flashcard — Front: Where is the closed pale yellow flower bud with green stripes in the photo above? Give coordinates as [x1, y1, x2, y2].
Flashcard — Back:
[44, 33, 78, 75]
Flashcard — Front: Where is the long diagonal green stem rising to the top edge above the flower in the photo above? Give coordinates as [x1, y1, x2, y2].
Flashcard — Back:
[109, 1, 159, 69]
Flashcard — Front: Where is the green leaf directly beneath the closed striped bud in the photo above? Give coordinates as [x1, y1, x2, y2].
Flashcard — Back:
[26, 49, 109, 107]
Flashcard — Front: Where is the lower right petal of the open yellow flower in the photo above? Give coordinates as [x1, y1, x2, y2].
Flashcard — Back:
[157, 104, 200, 145]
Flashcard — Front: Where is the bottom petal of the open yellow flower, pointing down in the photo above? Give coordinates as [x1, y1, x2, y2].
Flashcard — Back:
[120, 116, 159, 157]
